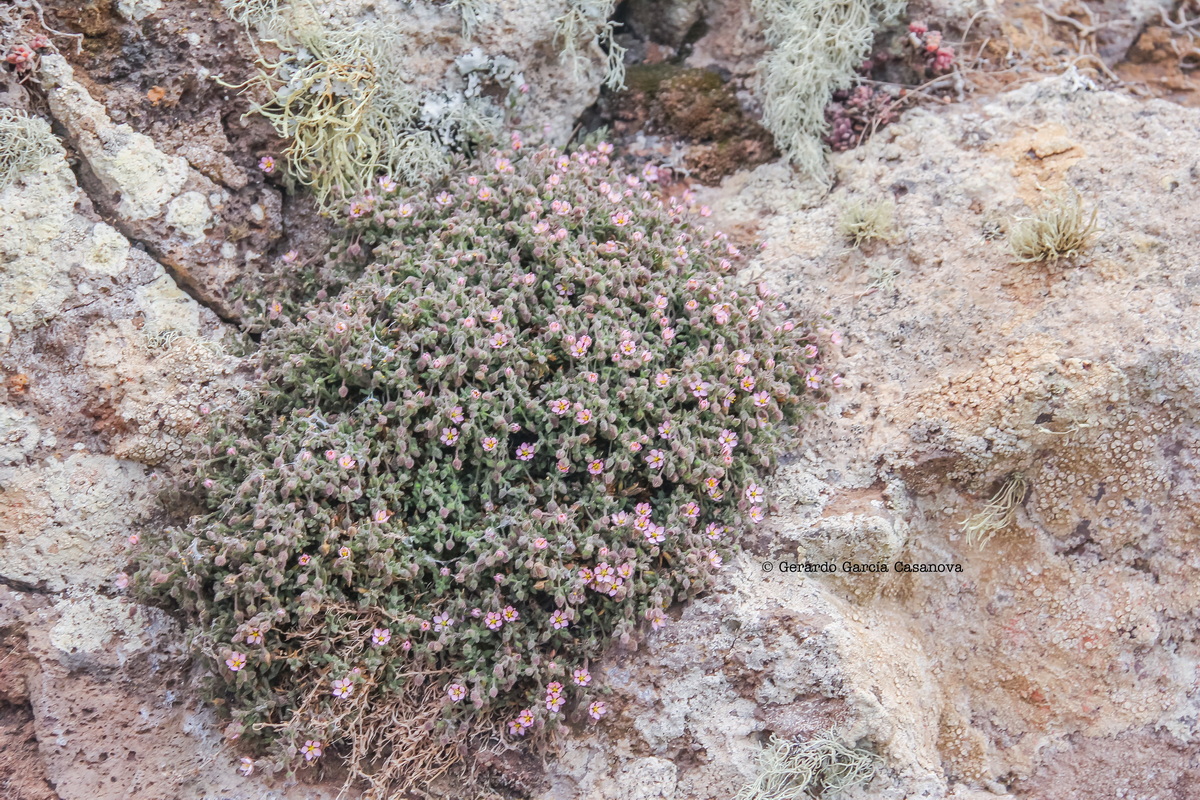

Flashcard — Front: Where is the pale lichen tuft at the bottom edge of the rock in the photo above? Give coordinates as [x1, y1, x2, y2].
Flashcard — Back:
[734, 730, 883, 800]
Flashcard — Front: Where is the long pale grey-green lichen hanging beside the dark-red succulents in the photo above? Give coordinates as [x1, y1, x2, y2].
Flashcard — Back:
[752, 0, 906, 179]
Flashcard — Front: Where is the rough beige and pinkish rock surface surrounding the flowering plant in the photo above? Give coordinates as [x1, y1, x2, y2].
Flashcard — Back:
[0, 0, 1200, 800]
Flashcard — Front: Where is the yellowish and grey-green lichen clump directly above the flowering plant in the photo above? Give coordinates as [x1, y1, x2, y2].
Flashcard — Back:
[223, 0, 524, 211]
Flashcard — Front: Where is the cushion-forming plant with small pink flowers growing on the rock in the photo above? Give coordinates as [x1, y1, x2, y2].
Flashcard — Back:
[138, 142, 836, 789]
